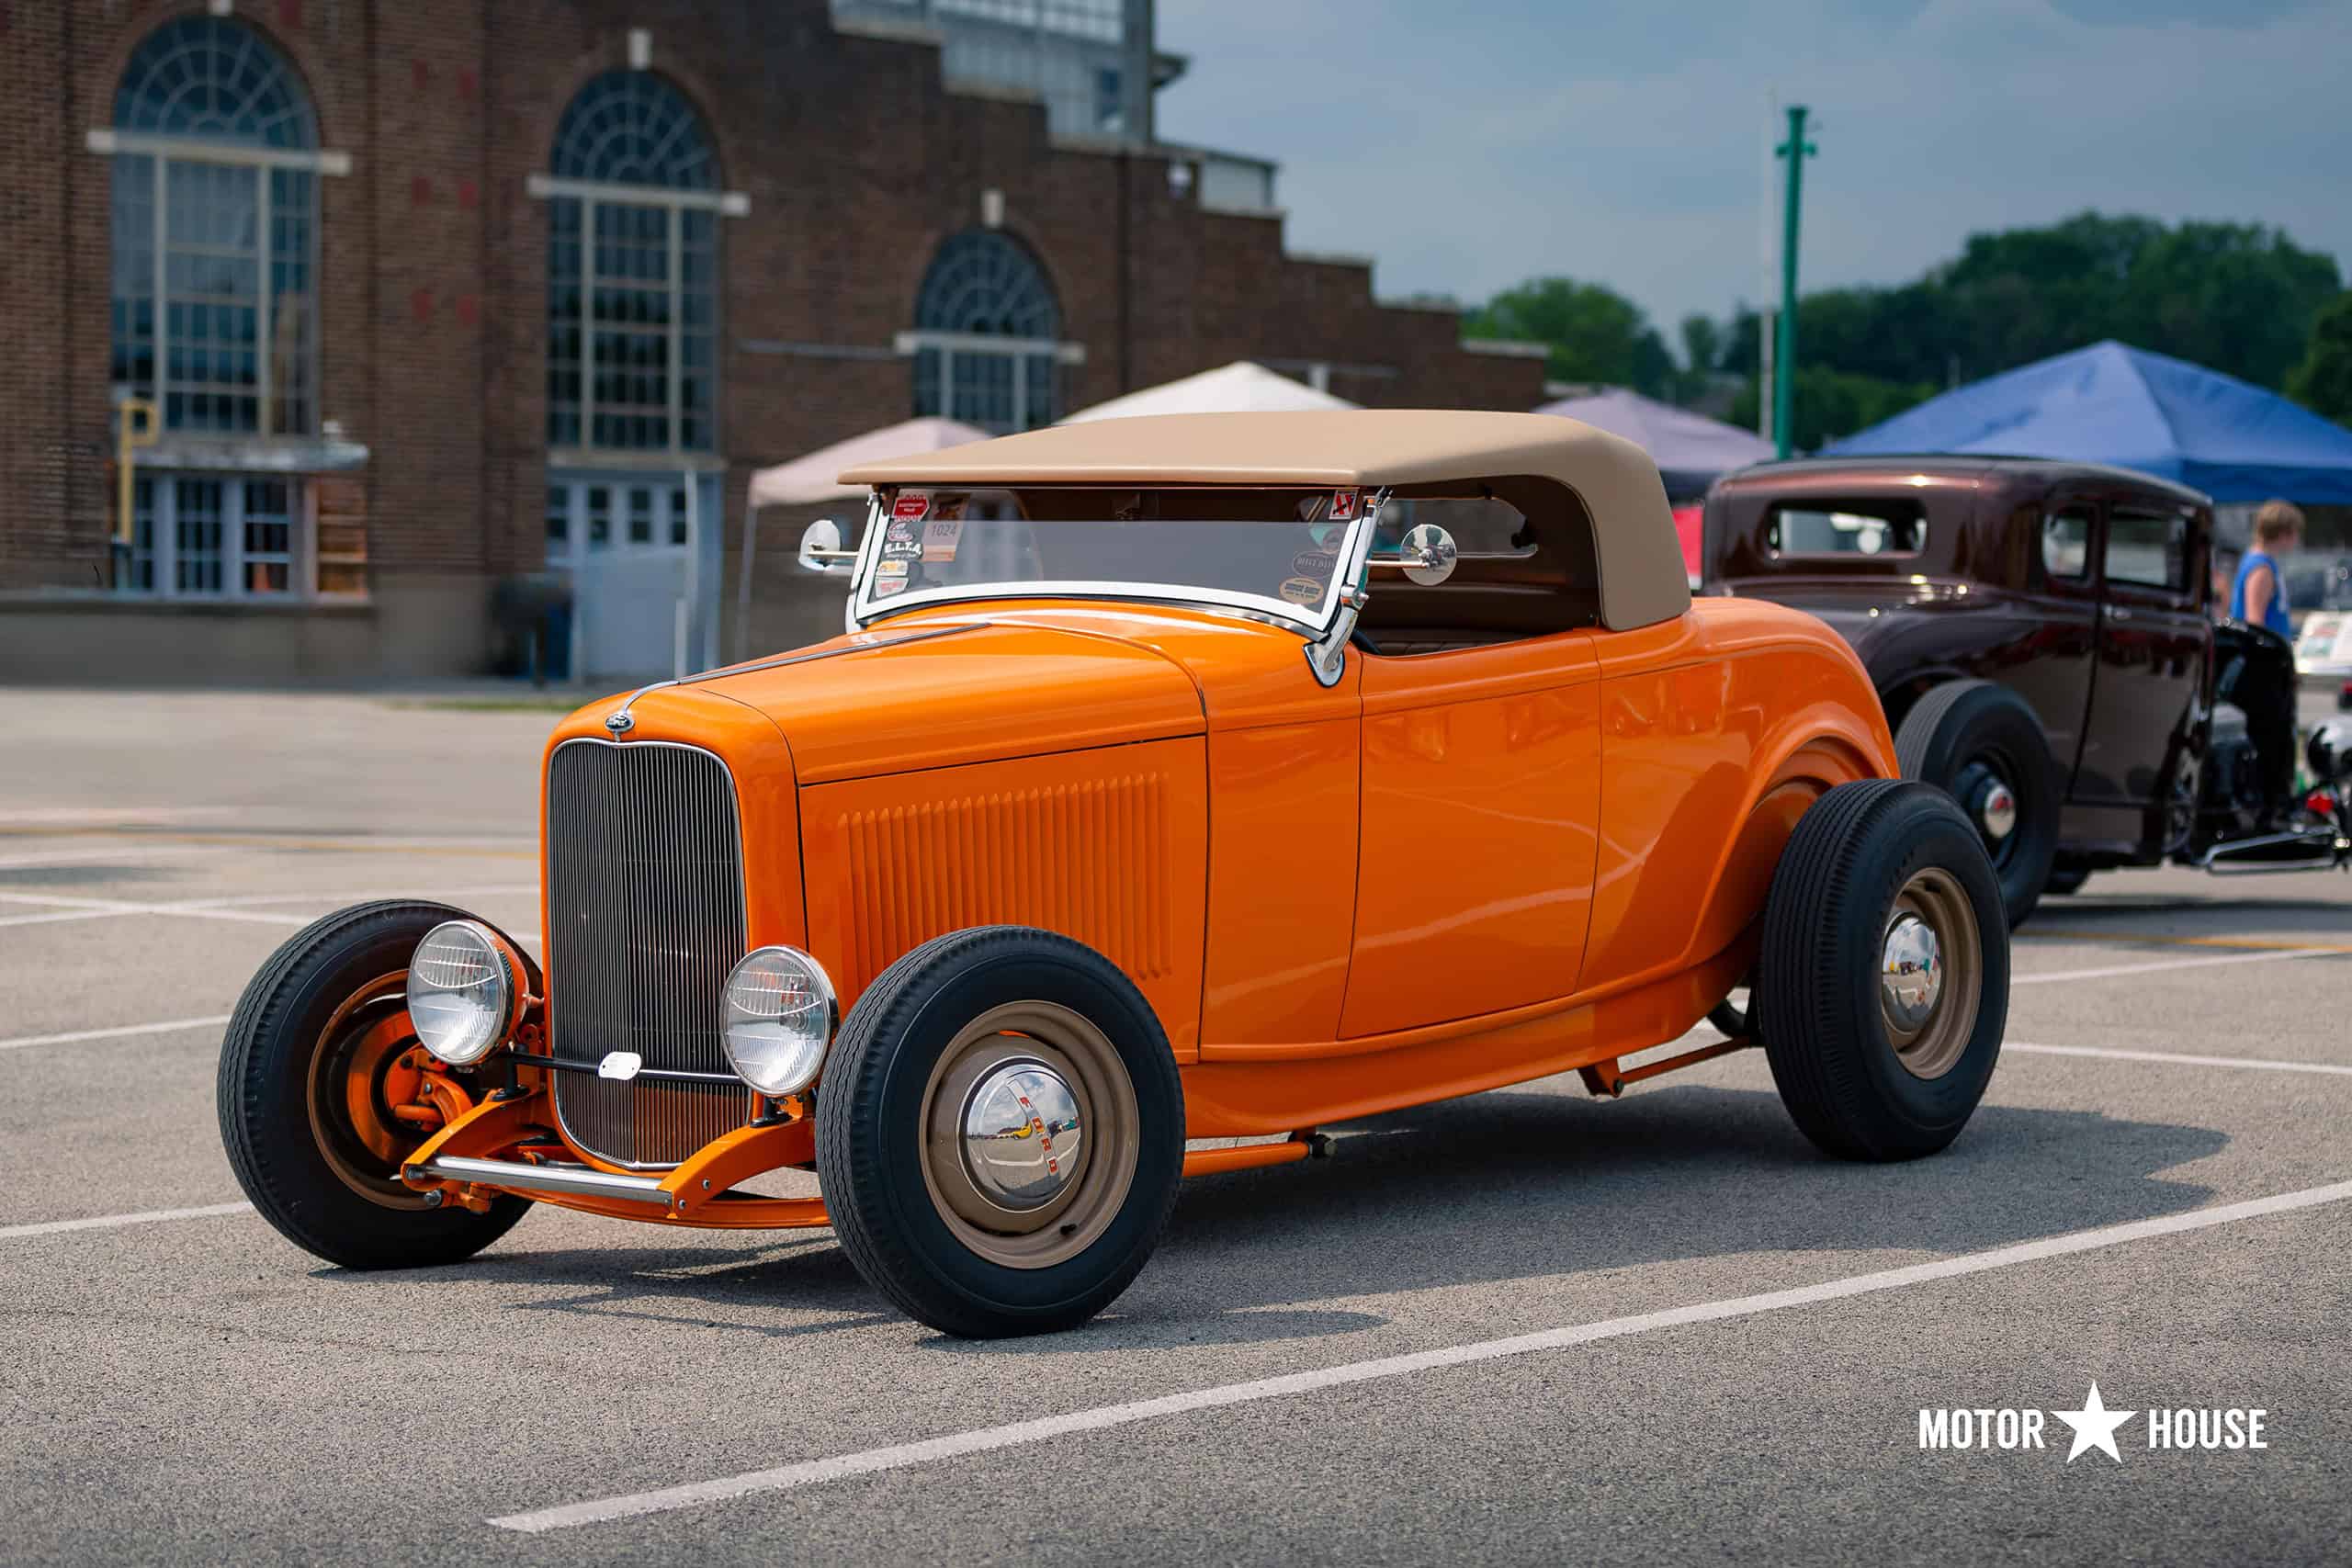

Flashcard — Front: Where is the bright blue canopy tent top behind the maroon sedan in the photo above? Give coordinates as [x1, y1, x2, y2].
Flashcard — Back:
[1826, 341, 2352, 505]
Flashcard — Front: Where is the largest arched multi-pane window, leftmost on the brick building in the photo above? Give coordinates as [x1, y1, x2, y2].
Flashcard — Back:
[113, 17, 318, 437]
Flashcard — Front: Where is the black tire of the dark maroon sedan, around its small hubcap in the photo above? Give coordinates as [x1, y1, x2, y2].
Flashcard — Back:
[1895, 680, 2061, 926]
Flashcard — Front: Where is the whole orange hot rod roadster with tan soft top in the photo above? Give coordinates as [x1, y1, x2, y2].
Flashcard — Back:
[221, 412, 2008, 1336]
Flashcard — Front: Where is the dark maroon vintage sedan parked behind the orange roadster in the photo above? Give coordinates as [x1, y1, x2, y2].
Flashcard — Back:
[1702, 456, 2352, 919]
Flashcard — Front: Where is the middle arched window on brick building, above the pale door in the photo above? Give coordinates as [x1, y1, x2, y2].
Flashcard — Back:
[548, 71, 722, 451]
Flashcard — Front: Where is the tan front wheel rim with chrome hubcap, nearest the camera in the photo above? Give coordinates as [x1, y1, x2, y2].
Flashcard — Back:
[922, 1001, 1141, 1269]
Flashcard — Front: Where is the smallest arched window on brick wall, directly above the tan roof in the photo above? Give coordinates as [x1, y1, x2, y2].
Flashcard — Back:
[910, 228, 1061, 430]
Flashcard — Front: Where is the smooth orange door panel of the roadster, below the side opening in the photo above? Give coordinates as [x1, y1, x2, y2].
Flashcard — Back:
[1340, 632, 1601, 1039]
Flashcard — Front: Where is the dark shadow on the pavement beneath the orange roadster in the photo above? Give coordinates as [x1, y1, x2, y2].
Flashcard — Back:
[336, 1084, 2227, 1354]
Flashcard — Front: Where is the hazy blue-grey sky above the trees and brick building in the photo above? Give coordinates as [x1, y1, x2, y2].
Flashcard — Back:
[1159, 0, 2352, 350]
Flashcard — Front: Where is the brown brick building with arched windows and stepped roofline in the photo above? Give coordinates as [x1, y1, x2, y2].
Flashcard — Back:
[0, 0, 1543, 682]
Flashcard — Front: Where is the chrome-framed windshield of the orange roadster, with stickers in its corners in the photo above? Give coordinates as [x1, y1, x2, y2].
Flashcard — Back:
[858, 484, 1364, 627]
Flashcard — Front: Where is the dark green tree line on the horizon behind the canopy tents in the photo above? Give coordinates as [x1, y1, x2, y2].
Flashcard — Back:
[1463, 211, 2352, 449]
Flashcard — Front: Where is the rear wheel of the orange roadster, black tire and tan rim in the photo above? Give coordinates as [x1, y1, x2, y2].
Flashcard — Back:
[1755, 778, 2008, 1159]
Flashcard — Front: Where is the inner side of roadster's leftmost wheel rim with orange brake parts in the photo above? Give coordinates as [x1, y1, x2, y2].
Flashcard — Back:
[308, 971, 425, 1211]
